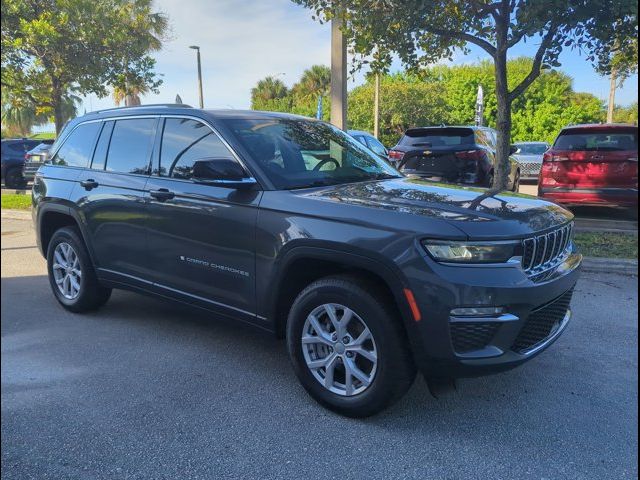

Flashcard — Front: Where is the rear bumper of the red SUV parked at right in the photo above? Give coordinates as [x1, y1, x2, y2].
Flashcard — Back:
[538, 187, 638, 207]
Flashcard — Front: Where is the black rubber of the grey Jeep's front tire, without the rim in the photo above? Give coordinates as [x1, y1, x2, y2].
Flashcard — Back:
[287, 275, 416, 417]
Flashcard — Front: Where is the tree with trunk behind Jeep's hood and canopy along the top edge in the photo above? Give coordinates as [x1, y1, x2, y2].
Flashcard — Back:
[293, 0, 638, 188]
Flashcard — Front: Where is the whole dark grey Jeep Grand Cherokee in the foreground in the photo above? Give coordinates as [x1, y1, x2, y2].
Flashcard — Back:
[33, 105, 581, 416]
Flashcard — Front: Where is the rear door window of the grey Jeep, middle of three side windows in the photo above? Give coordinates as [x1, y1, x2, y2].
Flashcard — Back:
[105, 118, 157, 175]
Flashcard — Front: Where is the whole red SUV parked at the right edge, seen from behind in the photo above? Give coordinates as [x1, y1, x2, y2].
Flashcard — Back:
[538, 124, 638, 208]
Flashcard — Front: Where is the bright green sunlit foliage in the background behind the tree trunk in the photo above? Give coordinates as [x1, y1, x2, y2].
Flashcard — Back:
[348, 57, 604, 146]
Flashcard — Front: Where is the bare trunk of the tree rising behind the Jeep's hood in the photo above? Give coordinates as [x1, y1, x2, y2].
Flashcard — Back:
[493, 50, 511, 190]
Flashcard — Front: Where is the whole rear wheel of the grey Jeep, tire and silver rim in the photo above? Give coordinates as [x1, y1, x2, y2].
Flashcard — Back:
[47, 227, 111, 312]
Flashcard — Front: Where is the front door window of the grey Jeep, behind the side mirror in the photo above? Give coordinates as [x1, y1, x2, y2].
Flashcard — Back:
[153, 118, 235, 180]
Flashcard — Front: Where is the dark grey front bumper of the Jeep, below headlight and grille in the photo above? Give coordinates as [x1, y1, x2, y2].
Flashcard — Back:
[402, 251, 582, 378]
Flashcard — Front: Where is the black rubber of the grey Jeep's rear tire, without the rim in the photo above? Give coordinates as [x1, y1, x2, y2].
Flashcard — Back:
[47, 227, 111, 313]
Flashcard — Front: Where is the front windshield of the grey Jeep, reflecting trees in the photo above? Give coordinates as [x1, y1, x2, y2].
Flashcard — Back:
[224, 118, 402, 190]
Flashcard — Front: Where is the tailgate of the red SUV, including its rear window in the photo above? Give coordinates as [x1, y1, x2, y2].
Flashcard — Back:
[550, 126, 638, 188]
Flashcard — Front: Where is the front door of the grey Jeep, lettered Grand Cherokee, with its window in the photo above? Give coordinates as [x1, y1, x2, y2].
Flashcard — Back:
[145, 118, 262, 320]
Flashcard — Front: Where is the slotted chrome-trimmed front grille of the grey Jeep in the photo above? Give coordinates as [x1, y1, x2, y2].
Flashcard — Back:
[522, 222, 573, 281]
